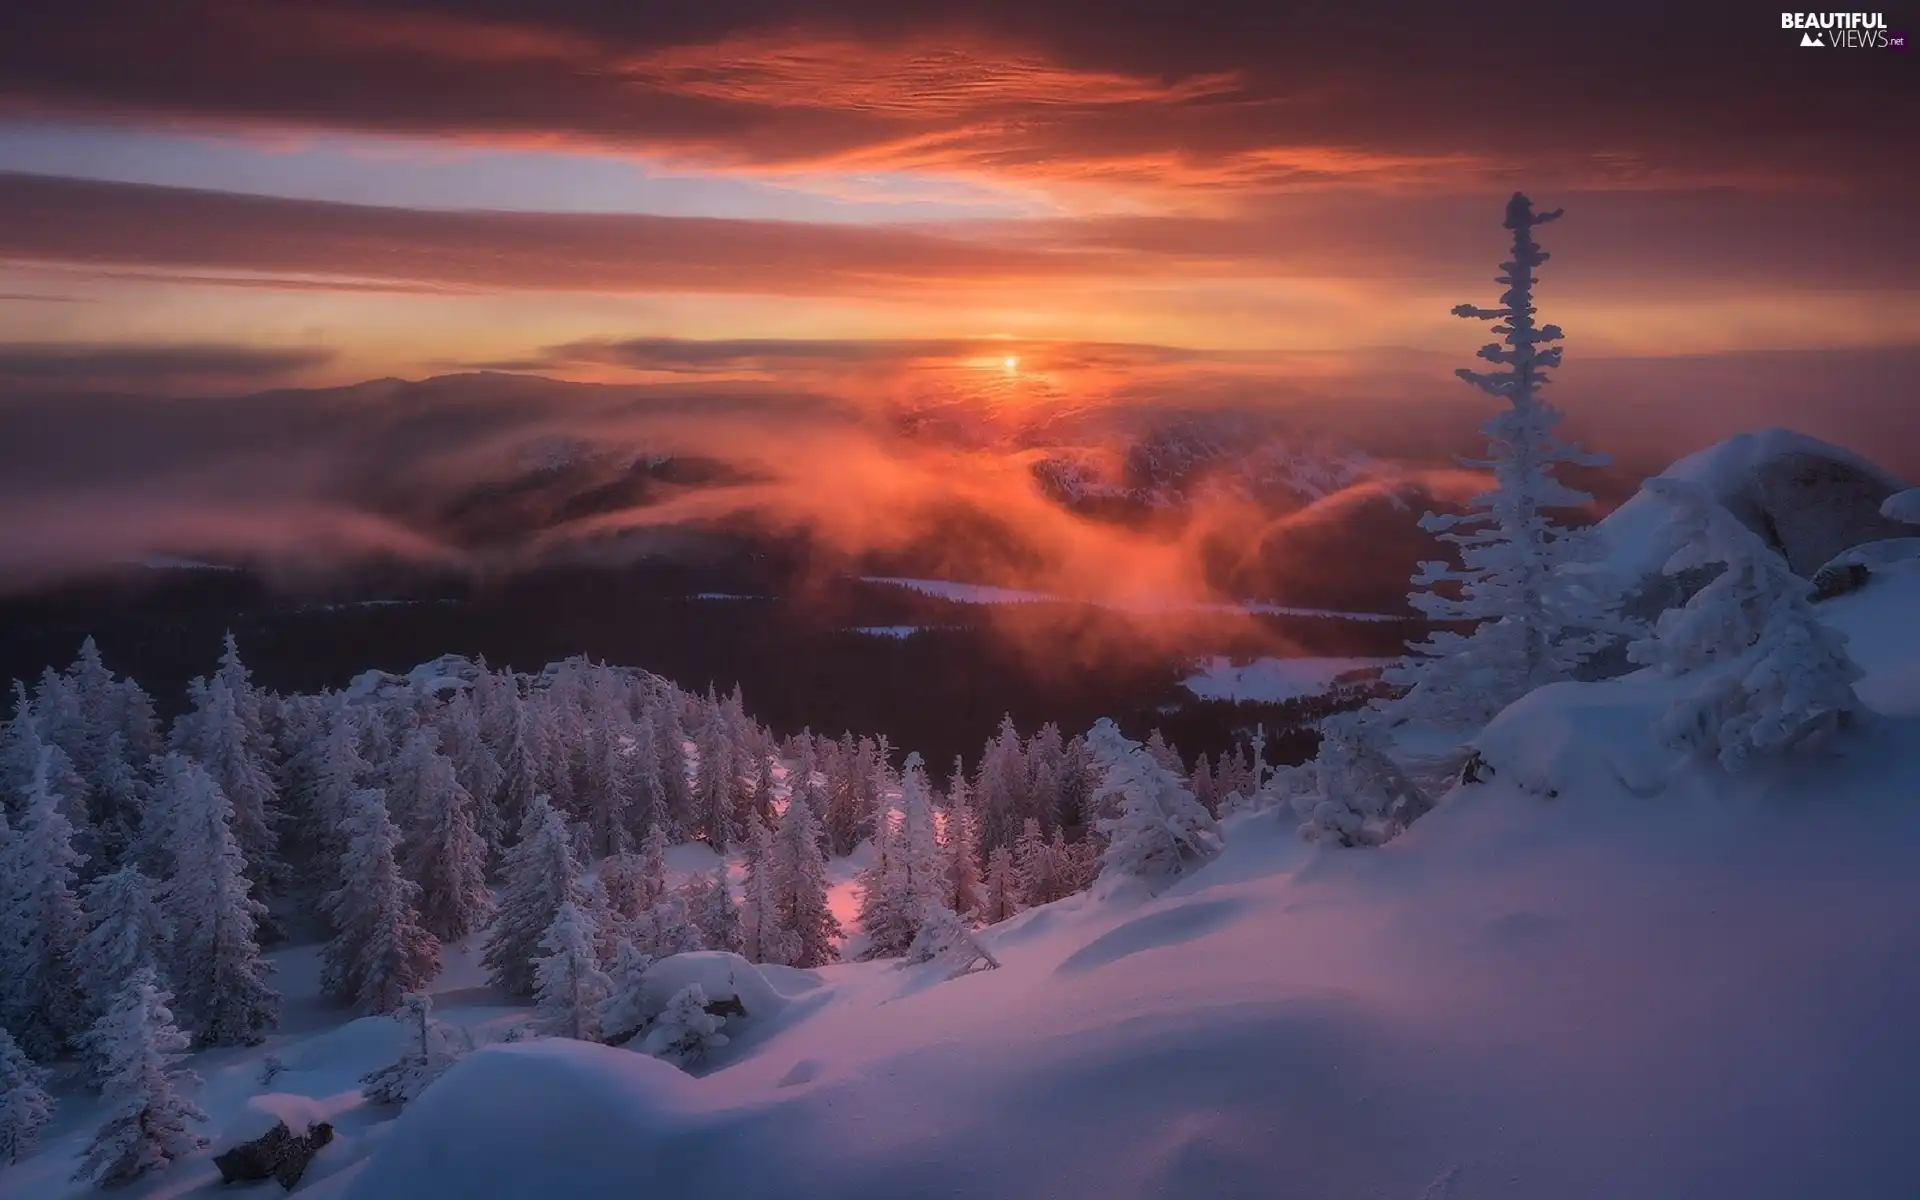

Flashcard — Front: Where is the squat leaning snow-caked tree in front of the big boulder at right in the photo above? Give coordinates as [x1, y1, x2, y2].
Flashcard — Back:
[1628, 478, 1862, 770]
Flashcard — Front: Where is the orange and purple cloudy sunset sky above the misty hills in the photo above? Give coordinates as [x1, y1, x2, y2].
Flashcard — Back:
[0, 0, 1920, 587]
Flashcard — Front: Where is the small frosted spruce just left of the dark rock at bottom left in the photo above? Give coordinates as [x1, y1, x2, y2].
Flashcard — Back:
[75, 968, 207, 1187]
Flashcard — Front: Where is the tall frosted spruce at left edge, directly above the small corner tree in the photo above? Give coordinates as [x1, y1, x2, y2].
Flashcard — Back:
[0, 747, 86, 1062]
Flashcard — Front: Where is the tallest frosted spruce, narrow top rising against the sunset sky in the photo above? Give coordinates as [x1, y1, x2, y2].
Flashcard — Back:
[1386, 192, 1624, 726]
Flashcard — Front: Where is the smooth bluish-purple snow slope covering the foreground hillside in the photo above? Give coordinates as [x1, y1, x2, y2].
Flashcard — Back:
[18, 533, 1920, 1200]
